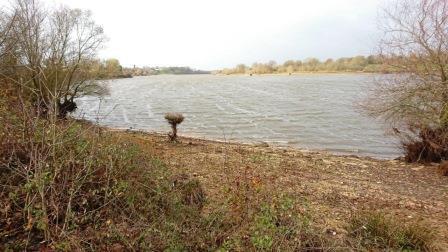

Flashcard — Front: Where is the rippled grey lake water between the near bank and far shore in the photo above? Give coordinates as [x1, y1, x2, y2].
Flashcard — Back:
[76, 74, 401, 159]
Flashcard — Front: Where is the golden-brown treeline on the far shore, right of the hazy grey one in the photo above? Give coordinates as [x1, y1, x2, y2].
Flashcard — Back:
[214, 55, 393, 74]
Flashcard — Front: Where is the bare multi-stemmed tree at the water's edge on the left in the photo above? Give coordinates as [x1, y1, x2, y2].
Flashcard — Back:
[4, 0, 105, 117]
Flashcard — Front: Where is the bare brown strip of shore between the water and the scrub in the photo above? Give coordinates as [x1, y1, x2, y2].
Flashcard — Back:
[119, 133, 448, 248]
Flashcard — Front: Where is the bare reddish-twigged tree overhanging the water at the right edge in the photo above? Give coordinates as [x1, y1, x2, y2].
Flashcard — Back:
[364, 0, 448, 159]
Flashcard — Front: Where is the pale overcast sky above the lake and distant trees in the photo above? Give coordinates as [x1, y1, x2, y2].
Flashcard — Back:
[0, 0, 384, 70]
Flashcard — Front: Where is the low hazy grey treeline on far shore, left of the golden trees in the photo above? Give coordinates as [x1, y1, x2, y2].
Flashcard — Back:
[124, 67, 210, 76]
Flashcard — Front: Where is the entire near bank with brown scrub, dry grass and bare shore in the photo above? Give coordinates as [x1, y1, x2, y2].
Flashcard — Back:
[0, 91, 448, 251]
